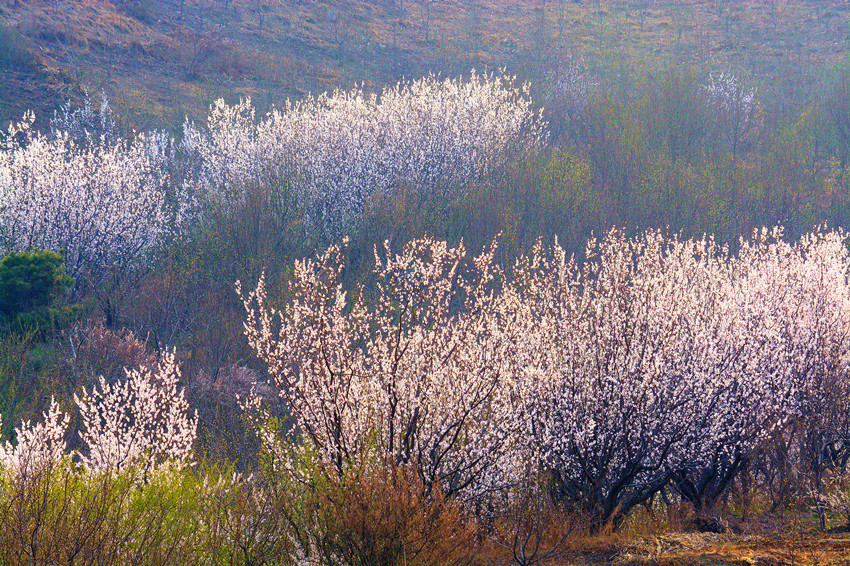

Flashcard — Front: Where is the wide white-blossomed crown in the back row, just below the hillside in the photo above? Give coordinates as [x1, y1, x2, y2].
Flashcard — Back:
[182, 73, 543, 236]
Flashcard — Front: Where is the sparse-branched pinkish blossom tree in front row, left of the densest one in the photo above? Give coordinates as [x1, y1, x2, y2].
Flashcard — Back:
[239, 239, 516, 495]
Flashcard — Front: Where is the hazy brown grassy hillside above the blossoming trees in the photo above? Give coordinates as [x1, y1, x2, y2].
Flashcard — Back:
[0, 0, 850, 129]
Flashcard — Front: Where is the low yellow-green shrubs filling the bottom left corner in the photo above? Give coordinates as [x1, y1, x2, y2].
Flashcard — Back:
[0, 459, 291, 566]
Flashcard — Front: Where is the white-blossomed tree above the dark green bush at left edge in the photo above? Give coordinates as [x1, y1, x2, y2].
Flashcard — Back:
[0, 115, 182, 288]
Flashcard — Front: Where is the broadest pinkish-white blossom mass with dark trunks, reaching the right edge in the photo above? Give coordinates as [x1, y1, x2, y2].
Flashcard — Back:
[499, 230, 850, 521]
